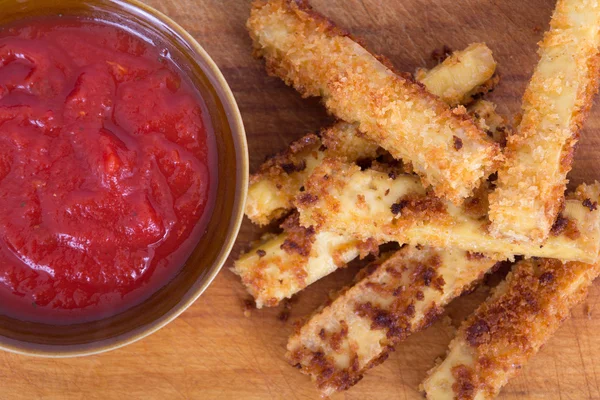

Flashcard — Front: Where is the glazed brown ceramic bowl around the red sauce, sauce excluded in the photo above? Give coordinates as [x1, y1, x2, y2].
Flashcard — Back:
[0, 0, 248, 357]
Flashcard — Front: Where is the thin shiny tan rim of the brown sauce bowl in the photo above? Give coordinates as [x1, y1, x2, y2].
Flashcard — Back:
[0, 0, 249, 358]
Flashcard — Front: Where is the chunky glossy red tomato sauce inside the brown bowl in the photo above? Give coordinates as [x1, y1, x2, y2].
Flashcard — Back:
[0, 17, 216, 324]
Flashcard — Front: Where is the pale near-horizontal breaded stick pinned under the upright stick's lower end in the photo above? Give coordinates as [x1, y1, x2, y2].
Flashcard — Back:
[296, 159, 600, 263]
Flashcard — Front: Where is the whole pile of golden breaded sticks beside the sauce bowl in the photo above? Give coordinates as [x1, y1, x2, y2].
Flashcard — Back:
[233, 0, 600, 399]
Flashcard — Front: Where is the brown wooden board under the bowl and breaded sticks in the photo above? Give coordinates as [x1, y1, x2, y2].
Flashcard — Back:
[0, 0, 600, 400]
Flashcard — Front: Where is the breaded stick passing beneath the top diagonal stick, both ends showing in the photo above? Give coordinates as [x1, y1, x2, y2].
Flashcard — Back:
[246, 43, 497, 225]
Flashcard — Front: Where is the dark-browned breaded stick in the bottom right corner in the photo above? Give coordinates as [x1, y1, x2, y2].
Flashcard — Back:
[421, 259, 600, 400]
